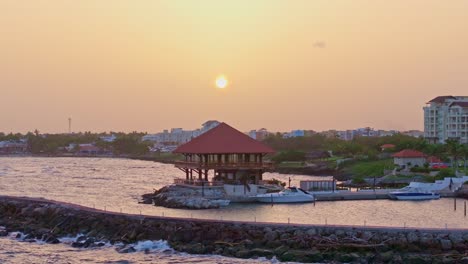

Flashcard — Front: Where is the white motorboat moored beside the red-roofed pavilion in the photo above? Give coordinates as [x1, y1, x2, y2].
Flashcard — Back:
[254, 187, 315, 203]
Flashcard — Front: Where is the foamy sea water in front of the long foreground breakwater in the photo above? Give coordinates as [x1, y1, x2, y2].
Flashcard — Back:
[0, 233, 278, 264]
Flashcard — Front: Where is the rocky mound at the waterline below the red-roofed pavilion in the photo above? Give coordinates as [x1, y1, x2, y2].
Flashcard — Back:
[142, 185, 229, 209]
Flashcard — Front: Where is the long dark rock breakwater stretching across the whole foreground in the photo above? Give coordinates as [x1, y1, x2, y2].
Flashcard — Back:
[0, 196, 468, 263]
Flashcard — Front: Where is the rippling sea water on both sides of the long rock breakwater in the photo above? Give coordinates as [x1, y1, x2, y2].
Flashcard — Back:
[0, 157, 468, 263]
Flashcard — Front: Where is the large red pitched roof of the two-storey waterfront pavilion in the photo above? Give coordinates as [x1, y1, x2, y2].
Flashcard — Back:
[173, 123, 275, 154]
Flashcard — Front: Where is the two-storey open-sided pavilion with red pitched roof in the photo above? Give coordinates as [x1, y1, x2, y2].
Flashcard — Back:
[173, 123, 274, 185]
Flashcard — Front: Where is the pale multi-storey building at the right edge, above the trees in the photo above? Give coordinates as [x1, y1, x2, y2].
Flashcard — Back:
[423, 95, 468, 144]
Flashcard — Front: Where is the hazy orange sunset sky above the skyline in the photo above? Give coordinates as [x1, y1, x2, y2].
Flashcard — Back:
[0, 0, 468, 133]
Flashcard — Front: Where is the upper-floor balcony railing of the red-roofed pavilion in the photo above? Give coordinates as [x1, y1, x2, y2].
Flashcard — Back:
[175, 161, 274, 169]
